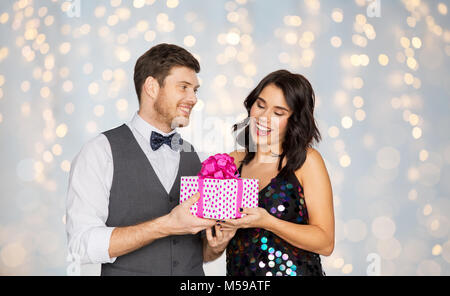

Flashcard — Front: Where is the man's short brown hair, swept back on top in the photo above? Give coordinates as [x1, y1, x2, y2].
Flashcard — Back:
[134, 43, 200, 103]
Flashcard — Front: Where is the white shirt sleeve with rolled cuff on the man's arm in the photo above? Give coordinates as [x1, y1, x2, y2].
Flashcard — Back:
[66, 134, 116, 264]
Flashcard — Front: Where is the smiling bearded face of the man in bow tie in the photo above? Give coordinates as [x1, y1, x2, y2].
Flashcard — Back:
[154, 67, 199, 128]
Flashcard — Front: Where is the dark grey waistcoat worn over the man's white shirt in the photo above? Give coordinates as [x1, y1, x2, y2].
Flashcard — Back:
[101, 124, 204, 276]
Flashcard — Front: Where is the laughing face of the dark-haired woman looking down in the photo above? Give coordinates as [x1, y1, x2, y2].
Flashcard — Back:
[250, 84, 292, 145]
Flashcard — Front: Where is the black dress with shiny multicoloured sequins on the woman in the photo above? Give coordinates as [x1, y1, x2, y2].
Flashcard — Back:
[226, 165, 325, 276]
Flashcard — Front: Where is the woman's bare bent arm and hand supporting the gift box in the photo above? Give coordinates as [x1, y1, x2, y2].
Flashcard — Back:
[222, 149, 334, 256]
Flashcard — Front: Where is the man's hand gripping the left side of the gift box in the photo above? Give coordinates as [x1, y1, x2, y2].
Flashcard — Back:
[167, 192, 216, 235]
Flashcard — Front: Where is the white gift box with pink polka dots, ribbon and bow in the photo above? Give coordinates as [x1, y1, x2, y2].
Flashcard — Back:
[180, 154, 259, 219]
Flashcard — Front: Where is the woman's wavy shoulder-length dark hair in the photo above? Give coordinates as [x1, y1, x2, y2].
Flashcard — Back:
[233, 70, 321, 175]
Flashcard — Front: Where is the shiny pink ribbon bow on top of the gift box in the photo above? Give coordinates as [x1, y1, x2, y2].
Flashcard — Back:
[197, 153, 239, 179]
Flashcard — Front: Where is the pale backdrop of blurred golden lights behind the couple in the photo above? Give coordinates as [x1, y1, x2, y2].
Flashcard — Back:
[0, 0, 450, 275]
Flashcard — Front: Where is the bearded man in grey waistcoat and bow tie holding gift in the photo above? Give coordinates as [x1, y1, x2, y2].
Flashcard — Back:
[66, 44, 223, 275]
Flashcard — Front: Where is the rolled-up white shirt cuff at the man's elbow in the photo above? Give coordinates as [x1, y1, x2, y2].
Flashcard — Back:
[87, 227, 117, 264]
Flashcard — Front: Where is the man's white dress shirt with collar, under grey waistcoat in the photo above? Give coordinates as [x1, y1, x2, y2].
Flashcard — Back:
[66, 113, 205, 264]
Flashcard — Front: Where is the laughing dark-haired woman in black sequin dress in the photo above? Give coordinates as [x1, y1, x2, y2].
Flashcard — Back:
[207, 70, 334, 276]
